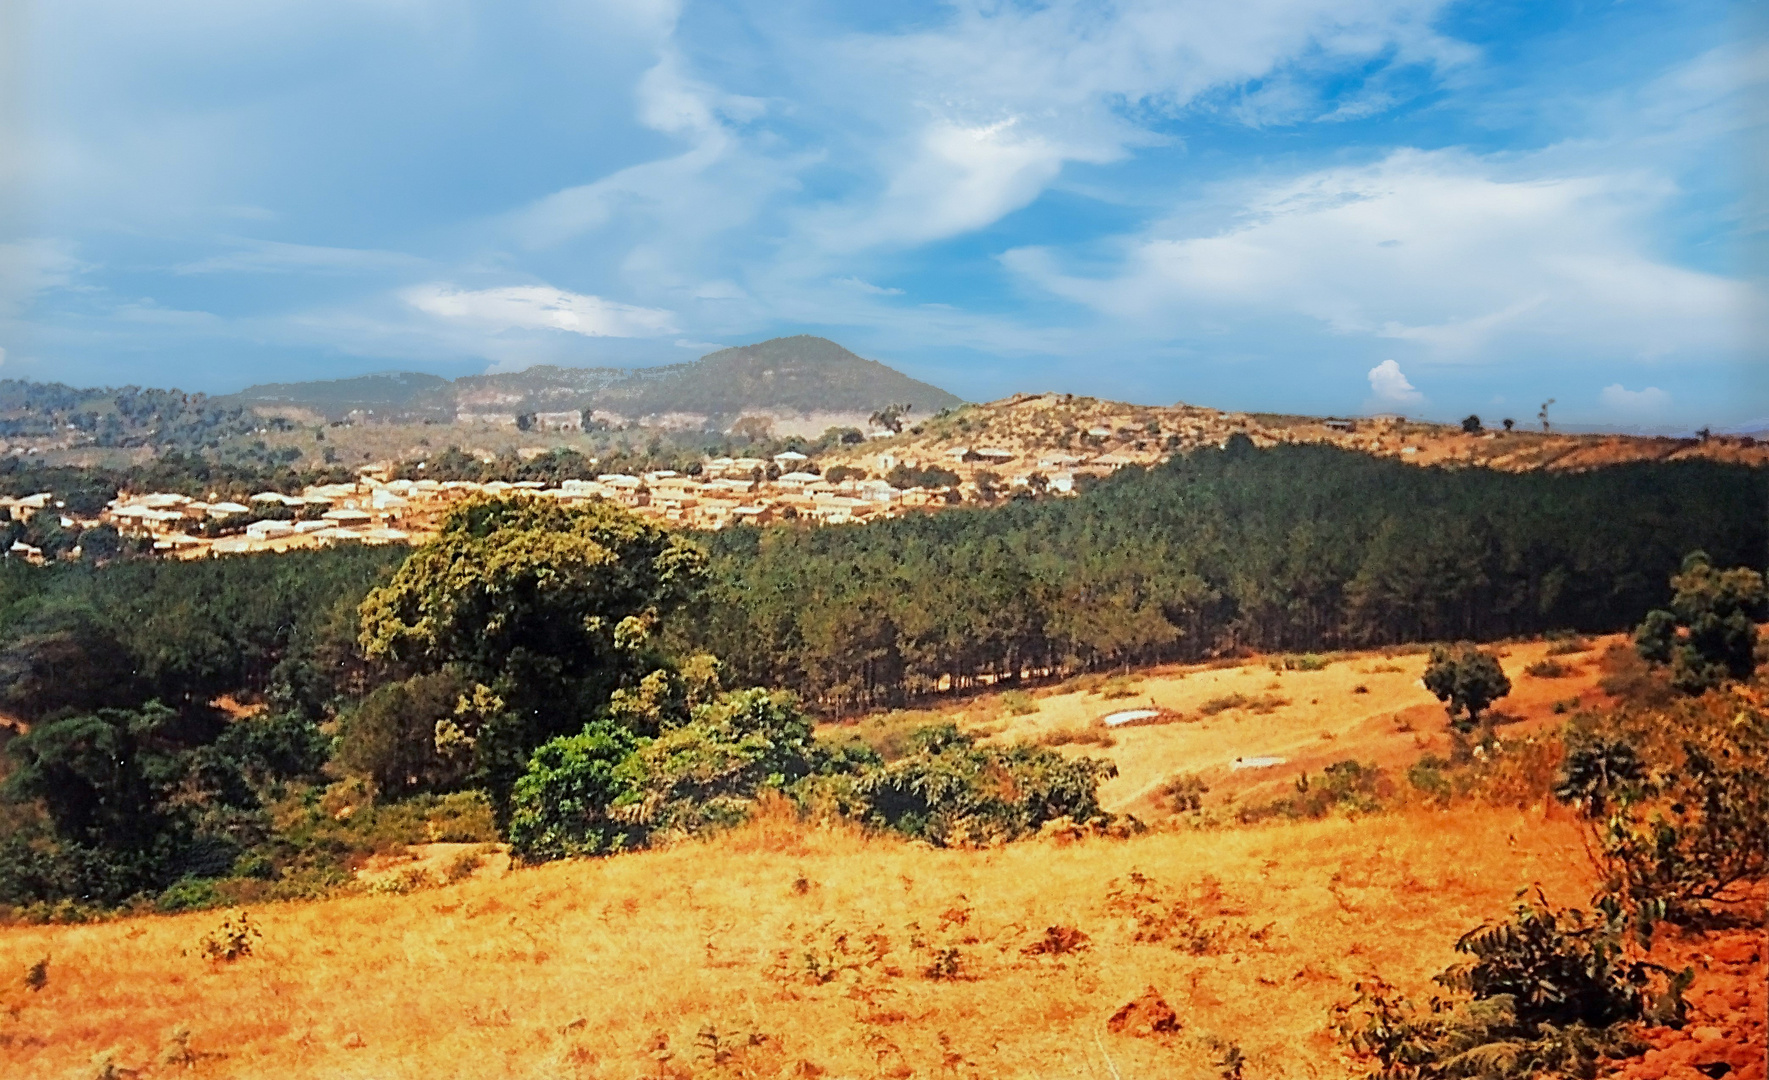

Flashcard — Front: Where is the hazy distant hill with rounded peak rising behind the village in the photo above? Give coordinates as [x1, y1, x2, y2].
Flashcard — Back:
[228, 334, 962, 428]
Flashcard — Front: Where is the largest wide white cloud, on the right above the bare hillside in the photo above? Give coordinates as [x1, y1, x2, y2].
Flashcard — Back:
[1003, 150, 1753, 362]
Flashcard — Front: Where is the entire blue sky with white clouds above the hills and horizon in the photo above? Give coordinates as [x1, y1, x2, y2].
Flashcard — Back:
[0, 0, 1769, 431]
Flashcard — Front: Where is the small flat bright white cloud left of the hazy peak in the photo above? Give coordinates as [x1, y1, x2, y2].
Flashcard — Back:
[400, 285, 676, 338]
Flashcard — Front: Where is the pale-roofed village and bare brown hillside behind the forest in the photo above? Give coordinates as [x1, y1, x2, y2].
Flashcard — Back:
[0, 394, 1769, 562]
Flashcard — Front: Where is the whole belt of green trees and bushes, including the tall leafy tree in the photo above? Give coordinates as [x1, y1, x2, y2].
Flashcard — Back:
[0, 442, 1769, 910]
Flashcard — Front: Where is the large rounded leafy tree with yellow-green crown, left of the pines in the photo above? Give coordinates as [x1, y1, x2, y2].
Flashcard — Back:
[361, 497, 704, 801]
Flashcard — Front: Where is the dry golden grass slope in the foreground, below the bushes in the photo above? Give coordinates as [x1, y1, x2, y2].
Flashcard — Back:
[0, 810, 1590, 1080]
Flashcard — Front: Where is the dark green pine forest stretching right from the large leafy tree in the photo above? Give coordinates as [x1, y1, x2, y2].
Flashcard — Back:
[679, 440, 1769, 707]
